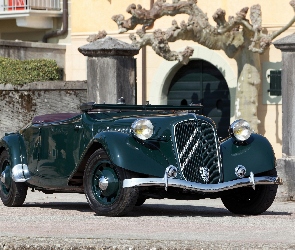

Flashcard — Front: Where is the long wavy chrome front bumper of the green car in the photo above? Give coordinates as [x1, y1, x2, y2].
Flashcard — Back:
[123, 176, 282, 193]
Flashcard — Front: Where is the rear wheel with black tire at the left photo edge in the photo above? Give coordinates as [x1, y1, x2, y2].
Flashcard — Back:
[0, 150, 28, 207]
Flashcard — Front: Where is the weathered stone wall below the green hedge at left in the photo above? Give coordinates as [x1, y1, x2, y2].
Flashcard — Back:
[0, 81, 87, 138]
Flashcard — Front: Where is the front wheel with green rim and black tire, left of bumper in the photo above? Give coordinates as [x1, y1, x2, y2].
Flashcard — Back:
[83, 149, 138, 216]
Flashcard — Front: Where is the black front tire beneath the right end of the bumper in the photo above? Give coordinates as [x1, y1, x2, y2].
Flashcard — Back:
[221, 169, 278, 215]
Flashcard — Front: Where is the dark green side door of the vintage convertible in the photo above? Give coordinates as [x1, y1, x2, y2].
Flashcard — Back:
[36, 117, 83, 187]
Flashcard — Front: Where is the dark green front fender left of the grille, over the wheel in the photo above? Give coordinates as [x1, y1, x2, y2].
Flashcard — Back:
[94, 132, 169, 177]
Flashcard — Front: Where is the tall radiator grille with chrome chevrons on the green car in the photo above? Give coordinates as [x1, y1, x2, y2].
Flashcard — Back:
[174, 119, 220, 183]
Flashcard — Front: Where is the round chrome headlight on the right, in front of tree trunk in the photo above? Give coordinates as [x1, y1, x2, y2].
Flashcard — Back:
[229, 119, 252, 141]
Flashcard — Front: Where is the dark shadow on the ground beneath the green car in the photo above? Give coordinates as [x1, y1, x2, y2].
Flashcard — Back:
[23, 202, 291, 217]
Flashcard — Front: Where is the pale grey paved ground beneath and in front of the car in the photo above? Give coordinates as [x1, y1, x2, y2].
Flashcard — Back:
[0, 189, 295, 250]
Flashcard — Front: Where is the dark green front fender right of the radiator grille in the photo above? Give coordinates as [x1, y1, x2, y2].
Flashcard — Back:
[220, 134, 275, 181]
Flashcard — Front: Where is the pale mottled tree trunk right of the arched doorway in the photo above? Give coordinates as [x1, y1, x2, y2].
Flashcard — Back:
[235, 46, 261, 132]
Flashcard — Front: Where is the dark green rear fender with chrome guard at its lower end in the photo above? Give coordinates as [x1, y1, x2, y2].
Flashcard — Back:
[0, 133, 30, 182]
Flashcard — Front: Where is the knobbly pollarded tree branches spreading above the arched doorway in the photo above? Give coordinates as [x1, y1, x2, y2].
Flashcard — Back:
[112, 0, 295, 63]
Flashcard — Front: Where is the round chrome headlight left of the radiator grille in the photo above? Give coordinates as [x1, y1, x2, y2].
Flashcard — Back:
[131, 119, 154, 140]
